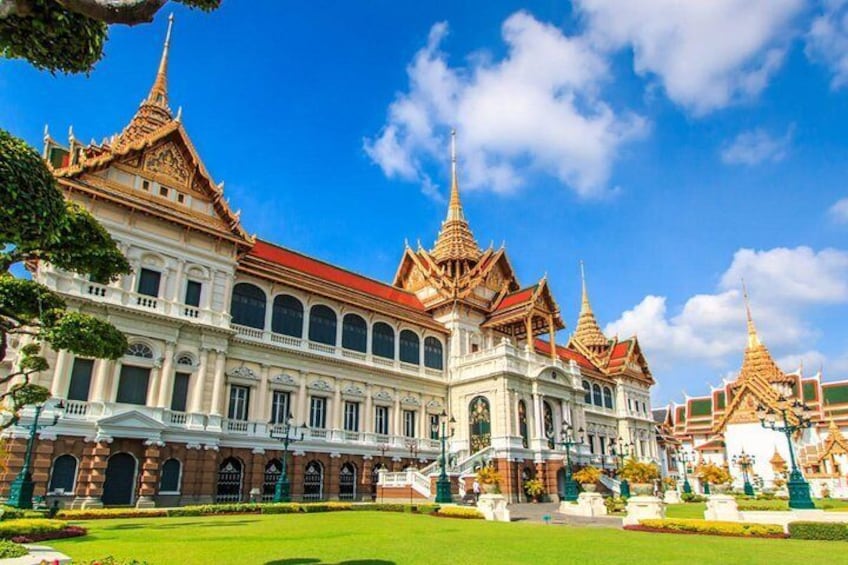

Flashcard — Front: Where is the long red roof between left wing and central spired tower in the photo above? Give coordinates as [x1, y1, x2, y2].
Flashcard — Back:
[249, 240, 424, 311]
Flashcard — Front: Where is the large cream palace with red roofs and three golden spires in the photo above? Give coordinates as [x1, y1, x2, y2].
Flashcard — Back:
[0, 18, 659, 507]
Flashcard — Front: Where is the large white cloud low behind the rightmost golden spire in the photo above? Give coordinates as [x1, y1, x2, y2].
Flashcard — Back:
[605, 247, 848, 379]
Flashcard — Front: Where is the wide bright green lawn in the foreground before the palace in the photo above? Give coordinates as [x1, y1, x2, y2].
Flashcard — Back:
[49, 512, 844, 565]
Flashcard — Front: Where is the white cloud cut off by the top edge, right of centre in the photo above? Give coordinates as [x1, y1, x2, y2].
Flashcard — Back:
[576, 0, 805, 115]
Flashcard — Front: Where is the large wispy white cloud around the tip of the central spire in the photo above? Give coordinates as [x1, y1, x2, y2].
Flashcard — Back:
[364, 12, 647, 197]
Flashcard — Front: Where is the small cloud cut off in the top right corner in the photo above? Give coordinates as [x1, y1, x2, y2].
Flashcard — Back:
[805, 0, 848, 89]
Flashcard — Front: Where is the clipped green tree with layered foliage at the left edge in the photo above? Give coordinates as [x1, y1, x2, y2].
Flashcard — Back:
[0, 129, 130, 428]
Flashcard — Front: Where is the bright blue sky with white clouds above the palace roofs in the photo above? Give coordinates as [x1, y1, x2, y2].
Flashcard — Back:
[0, 0, 848, 405]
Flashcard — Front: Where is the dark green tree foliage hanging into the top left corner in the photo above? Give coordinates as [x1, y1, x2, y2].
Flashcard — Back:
[0, 0, 221, 73]
